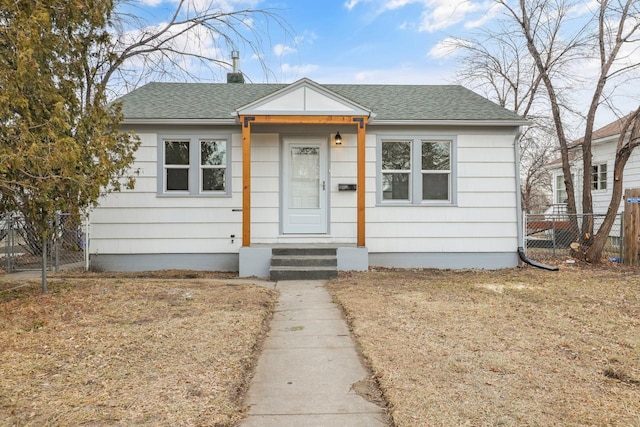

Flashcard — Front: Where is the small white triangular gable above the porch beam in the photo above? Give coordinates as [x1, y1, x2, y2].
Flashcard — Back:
[237, 79, 371, 116]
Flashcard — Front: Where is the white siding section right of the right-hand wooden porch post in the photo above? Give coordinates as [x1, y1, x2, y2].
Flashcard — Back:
[366, 128, 518, 255]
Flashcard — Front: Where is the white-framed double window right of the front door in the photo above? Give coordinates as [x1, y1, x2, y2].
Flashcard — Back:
[379, 137, 455, 205]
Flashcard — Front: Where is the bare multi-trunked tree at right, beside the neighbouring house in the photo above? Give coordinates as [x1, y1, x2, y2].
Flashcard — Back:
[466, 0, 640, 262]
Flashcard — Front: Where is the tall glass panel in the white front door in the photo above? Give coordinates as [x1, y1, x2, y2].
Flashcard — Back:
[289, 147, 320, 209]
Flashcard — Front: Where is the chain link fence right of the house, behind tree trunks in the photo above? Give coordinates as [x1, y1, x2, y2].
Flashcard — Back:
[524, 213, 624, 262]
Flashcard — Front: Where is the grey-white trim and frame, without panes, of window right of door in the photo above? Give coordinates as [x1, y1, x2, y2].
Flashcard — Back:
[376, 134, 458, 207]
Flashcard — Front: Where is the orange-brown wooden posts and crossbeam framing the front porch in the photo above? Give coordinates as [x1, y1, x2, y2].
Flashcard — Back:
[240, 115, 368, 247]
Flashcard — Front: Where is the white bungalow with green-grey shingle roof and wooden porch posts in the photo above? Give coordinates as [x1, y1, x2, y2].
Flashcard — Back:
[90, 79, 526, 276]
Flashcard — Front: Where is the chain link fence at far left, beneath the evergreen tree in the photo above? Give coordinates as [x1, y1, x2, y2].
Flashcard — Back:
[0, 212, 89, 273]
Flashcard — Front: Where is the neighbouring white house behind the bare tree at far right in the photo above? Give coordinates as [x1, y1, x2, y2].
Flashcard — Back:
[547, 113, 640, 217]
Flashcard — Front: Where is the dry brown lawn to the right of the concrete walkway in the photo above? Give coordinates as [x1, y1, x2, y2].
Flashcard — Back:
[329, 266, 640, 427]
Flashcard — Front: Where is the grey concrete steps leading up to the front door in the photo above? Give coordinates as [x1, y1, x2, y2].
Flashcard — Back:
[269, 248, 338, 282]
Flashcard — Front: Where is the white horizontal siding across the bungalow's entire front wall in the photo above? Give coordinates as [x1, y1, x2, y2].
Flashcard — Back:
[91, 126, 517, 257]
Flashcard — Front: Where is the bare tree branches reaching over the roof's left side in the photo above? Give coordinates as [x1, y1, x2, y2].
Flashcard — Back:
[92, 0, 291, 102]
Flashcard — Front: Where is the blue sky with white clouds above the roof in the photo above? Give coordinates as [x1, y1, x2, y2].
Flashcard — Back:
[119, 0, 640, 126]
